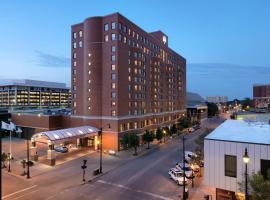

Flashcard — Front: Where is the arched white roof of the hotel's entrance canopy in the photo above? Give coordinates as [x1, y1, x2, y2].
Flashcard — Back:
[32, 126, 99, 142]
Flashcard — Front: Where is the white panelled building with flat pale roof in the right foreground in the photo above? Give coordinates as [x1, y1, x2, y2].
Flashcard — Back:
[204, 120, 270, 200]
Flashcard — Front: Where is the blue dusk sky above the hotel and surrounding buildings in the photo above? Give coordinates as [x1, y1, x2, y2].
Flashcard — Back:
[0, 0, 270, 99]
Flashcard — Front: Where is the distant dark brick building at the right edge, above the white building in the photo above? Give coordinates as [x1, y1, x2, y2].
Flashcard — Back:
[253, 84, 270, 111]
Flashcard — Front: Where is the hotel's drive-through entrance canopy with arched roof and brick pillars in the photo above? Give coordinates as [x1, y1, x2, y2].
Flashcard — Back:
[30, 126, 99, 166]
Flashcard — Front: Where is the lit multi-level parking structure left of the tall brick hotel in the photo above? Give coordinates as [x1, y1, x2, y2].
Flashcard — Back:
[0, 79, 70, 109]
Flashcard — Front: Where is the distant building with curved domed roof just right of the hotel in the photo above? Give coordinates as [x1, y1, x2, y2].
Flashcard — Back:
[187, 92, 207, 122]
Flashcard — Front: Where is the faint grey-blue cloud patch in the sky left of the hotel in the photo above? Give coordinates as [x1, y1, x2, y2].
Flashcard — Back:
[34, 50, 70, 67]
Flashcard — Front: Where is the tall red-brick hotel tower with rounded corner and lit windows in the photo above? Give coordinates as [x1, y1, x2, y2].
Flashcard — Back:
[71, 13, 186, 145]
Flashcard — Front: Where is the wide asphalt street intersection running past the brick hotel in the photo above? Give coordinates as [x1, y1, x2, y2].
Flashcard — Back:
[3, 116, 224, 200]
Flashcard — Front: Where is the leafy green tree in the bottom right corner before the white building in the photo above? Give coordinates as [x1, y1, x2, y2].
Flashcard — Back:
[239, 169, 270, 200]
